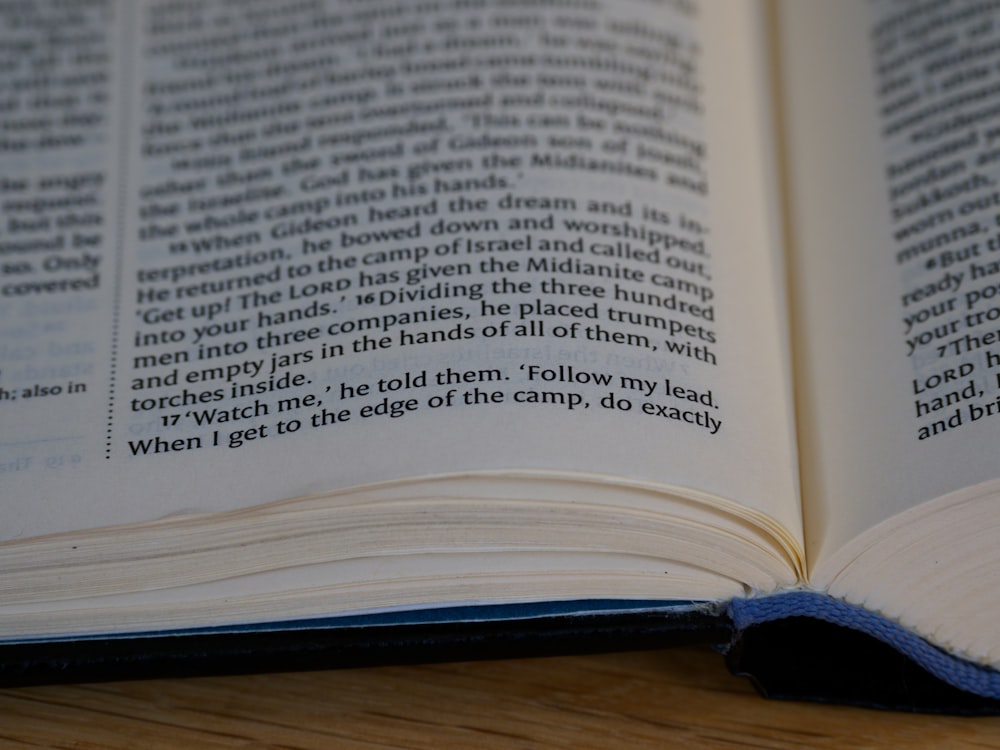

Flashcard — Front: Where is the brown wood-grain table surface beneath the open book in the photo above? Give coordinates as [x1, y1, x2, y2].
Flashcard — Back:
[0, 647, 1000, 750]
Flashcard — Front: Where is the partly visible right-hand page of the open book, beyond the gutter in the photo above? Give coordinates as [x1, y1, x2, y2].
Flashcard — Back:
[781, 2, 1000, 583]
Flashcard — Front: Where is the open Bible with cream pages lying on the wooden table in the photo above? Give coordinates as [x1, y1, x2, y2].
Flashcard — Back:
[0, 0, 1000, 712]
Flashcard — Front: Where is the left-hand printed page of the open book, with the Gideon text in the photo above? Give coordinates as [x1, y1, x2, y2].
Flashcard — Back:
[0, 0, 801, 545]
